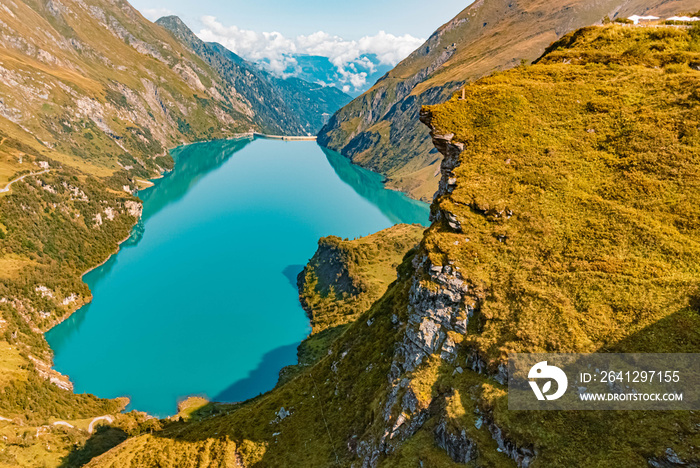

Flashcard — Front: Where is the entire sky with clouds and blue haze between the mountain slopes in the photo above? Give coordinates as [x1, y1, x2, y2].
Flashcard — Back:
[132, 0, 472, 92]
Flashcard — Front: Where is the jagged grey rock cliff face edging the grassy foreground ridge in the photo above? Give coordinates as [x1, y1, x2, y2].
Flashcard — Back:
[348, 108, 476, 467]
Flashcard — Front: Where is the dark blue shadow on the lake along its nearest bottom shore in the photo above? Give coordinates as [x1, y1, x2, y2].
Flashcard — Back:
[213, 343, 299, 403]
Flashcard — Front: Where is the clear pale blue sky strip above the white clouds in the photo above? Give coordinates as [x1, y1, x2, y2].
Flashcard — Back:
[131, 0, 471, 40]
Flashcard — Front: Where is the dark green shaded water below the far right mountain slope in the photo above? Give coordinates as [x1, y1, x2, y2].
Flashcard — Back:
[320, 147, 430, 226]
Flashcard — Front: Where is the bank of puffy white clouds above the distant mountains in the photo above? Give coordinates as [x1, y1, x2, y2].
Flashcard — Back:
[198, 16, 425, 90]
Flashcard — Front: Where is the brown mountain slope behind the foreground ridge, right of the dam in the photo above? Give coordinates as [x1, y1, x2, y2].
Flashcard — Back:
[319, 0, 697, 201]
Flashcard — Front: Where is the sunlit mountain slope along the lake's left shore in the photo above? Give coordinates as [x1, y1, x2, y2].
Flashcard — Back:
[0, 0, 322, 466]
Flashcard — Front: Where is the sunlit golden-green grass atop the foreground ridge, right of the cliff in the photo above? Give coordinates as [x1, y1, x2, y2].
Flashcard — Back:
[427, 22, 700, 358]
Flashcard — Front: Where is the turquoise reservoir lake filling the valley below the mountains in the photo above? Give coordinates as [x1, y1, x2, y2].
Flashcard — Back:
[46, 139, 429, 417]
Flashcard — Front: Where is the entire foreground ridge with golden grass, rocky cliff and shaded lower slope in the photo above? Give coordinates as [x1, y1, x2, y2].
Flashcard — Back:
[89, 26, 700, 468]
